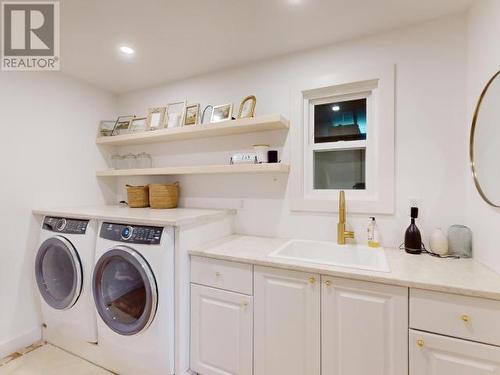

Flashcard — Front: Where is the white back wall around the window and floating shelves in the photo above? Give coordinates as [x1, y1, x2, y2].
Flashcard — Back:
[119, 15, 466, 250]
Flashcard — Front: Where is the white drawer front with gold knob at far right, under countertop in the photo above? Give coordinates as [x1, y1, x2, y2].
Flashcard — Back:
[410, 289, 500, 345]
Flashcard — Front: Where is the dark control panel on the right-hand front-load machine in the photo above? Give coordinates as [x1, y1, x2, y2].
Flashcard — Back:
[100, 223, 163, 245]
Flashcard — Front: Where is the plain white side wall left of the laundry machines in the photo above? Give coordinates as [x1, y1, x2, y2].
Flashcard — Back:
[0, 72, 116, 358]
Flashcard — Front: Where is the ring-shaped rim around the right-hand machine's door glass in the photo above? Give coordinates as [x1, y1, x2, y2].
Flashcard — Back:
[92, 245, 158, 336]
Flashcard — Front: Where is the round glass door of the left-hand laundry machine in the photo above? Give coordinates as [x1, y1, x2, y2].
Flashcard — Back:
[35, 236, 82, 310]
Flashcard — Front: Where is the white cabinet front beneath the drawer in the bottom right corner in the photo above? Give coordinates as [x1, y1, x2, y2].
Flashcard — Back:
[410, 330, 500, 375]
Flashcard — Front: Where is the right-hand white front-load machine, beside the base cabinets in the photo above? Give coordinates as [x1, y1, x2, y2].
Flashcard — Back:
[92, 222, 174, 375]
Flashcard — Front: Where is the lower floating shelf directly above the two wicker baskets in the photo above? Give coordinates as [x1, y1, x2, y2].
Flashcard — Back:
[96, 163, 290, 177]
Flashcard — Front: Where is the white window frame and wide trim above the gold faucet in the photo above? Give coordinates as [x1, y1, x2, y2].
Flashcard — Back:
[290, 65, 395, 214]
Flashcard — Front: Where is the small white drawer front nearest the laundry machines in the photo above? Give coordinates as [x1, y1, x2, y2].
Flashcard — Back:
[191, 256, 253, 295]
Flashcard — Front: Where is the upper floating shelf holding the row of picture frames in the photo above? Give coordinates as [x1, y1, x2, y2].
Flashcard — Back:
[96, 115, 290, 146]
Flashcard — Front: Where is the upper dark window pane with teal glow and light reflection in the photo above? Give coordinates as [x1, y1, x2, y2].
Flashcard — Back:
[314, 99, 366, 143]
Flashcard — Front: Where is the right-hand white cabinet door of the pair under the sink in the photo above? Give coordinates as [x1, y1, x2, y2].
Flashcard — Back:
[321, 277, 408, 375]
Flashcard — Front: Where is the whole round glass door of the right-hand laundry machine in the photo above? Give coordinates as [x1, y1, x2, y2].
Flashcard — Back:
[92, 246, 158, 336]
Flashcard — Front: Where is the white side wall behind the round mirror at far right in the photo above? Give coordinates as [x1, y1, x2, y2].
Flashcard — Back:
[466, 0, 500, 272]
